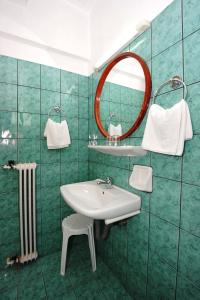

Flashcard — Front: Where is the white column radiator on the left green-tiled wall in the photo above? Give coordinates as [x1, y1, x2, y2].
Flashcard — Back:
[15, 163, 38, 263]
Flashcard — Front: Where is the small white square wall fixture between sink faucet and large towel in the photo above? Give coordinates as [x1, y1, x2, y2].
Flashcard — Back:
[129, 165, 153, 192]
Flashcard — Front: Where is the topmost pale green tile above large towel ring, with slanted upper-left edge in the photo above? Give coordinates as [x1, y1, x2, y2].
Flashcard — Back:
[152, 0, 182, 55]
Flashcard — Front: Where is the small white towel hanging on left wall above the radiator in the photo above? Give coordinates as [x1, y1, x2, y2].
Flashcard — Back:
[44, 119, 71, 149]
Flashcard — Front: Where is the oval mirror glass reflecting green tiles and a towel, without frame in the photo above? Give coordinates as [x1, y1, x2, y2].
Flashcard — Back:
[100, 57, 145, 137]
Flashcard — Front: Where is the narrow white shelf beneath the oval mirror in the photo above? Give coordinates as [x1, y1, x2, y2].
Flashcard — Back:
[88, 145, 147, 156]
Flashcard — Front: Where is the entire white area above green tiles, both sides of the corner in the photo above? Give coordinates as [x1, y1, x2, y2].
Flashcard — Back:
[0, 0, 173, 75]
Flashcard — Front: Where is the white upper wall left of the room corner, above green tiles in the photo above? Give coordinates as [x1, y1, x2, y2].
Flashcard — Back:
[0, 0, 90, 74]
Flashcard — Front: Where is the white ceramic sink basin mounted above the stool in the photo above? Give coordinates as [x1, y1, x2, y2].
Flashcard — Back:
[60, 180, 141, 224]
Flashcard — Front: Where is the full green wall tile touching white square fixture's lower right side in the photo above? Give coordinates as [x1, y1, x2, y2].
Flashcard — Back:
[150, 177, 181, 225]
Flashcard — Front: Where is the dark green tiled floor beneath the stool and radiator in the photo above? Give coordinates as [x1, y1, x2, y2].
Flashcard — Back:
[0, 239, 131, 300]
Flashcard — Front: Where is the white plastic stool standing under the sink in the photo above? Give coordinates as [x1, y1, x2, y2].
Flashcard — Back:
[60, 214, 96, 276]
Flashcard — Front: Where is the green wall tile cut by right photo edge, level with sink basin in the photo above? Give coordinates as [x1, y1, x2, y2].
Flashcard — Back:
[181, 184, 200, 237]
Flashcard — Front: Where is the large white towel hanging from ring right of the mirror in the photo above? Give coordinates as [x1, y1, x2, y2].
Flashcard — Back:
[142, 99, 193, 156]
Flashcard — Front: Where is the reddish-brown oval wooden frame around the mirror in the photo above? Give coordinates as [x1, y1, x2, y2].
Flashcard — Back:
[94, 52, 152, 140]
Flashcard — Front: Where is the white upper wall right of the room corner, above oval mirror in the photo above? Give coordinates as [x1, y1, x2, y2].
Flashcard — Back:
[90, 0, 172, 66]
